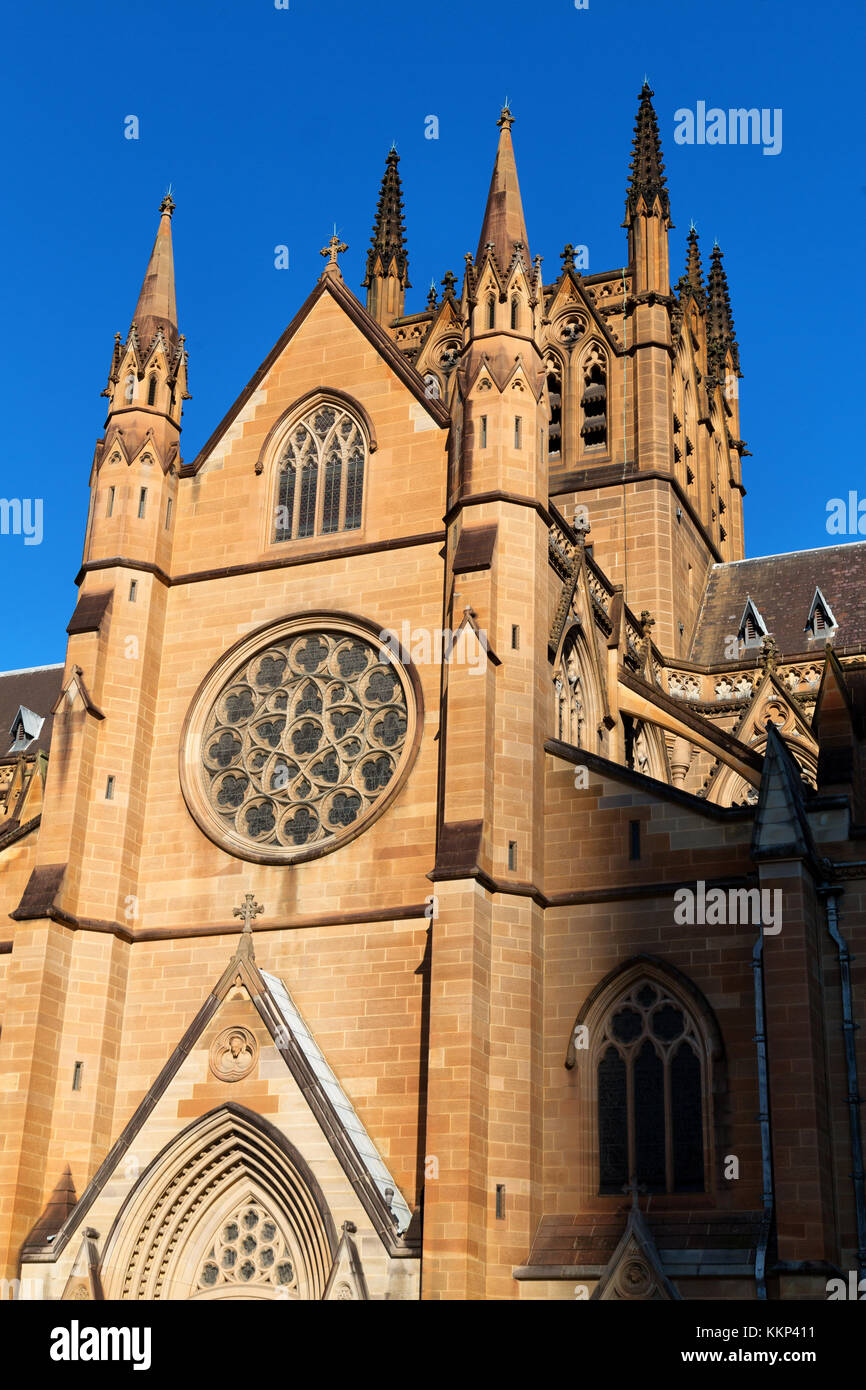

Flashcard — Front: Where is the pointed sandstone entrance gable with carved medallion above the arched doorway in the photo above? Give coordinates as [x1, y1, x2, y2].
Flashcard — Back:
[16, 934, 418, 1298]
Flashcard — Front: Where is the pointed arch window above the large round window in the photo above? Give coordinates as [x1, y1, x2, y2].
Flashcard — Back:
[272, 402, 367, 541]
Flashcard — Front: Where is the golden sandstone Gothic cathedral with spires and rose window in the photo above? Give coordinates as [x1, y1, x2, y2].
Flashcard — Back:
[0, 85, 866, 1300]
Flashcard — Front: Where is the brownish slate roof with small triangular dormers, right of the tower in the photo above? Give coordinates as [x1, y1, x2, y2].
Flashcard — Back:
[689, 541, 866, 666]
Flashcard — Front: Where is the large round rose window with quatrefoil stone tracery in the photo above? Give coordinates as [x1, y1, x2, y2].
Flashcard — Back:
[189, 624, 414, 862]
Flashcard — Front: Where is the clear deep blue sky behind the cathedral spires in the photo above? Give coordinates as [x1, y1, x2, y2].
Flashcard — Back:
[0, 0, 866, 669]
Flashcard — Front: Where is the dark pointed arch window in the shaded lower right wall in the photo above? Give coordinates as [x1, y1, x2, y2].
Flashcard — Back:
[592, 976, 709, 1194]
